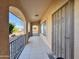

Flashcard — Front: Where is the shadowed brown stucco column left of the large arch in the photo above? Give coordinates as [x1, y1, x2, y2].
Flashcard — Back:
[0, 0, 9, 59]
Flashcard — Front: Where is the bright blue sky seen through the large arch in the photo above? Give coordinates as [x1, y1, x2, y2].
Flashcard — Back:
[9, 12, 24, 28]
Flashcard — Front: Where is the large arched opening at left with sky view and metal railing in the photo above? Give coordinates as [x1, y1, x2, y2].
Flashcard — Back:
[9, 6, 26, 59]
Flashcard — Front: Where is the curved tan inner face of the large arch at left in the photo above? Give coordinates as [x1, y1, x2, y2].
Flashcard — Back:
[9, 6, 26, 33]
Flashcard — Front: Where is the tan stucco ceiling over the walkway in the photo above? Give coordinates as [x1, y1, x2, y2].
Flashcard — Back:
[20, 0, 52, 21]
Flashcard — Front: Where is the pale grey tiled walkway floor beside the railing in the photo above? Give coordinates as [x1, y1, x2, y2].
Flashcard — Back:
[19, 36, 50, 59]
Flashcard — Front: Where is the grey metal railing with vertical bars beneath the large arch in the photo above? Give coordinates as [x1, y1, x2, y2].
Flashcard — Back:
[10, 35, 26, 59]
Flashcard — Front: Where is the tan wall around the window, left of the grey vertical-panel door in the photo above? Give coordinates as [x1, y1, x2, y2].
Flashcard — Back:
[41, 0, 68, 49]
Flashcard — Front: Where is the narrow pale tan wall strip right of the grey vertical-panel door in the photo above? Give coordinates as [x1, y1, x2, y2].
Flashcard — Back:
[74, 0, 79, 59]
